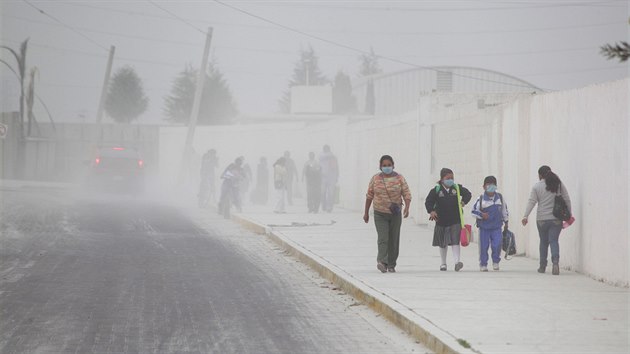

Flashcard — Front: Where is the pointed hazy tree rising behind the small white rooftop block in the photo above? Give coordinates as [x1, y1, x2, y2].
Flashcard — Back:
[279, 46, 328, 113]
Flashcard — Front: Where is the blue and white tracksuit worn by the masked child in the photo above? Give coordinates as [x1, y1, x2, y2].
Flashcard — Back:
[472, 193, 509, 267]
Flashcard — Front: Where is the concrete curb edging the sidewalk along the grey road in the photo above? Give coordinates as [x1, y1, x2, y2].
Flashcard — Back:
[232, 214, 480, 354]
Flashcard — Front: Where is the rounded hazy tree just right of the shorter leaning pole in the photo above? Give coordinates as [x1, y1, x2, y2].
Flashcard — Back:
[105, 66, 149, 123]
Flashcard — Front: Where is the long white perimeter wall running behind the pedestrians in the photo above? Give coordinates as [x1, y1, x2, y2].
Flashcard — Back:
[160, 80, 630, 286]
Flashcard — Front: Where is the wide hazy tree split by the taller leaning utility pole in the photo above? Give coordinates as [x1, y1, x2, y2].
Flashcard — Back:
[164, 63, 238, 125]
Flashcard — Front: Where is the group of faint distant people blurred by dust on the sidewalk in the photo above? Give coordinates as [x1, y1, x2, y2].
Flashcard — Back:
[198, 145, 339, 213]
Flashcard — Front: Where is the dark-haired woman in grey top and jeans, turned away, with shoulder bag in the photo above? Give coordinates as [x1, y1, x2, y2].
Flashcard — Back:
[521, 166, 571, 275]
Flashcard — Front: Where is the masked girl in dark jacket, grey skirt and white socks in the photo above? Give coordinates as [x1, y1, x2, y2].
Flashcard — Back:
[424, 168, 472, 272]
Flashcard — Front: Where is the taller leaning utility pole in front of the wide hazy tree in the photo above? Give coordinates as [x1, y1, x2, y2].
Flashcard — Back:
[178, 27, 212, 183]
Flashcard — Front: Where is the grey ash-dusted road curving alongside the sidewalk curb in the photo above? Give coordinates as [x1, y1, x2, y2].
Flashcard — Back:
[0, 186, 427, 353]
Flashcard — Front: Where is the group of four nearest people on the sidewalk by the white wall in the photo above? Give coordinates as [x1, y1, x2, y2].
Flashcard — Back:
[363, 155, 571, 275]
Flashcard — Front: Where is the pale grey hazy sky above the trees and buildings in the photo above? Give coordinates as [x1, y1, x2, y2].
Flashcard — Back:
[0, 0, 630, 123]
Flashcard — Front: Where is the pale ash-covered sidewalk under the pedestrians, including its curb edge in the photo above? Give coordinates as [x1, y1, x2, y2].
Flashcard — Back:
[236, 206, 630, 353]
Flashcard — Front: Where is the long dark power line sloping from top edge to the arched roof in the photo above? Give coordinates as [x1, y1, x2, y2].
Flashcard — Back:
[212, 0, 548, 88]
